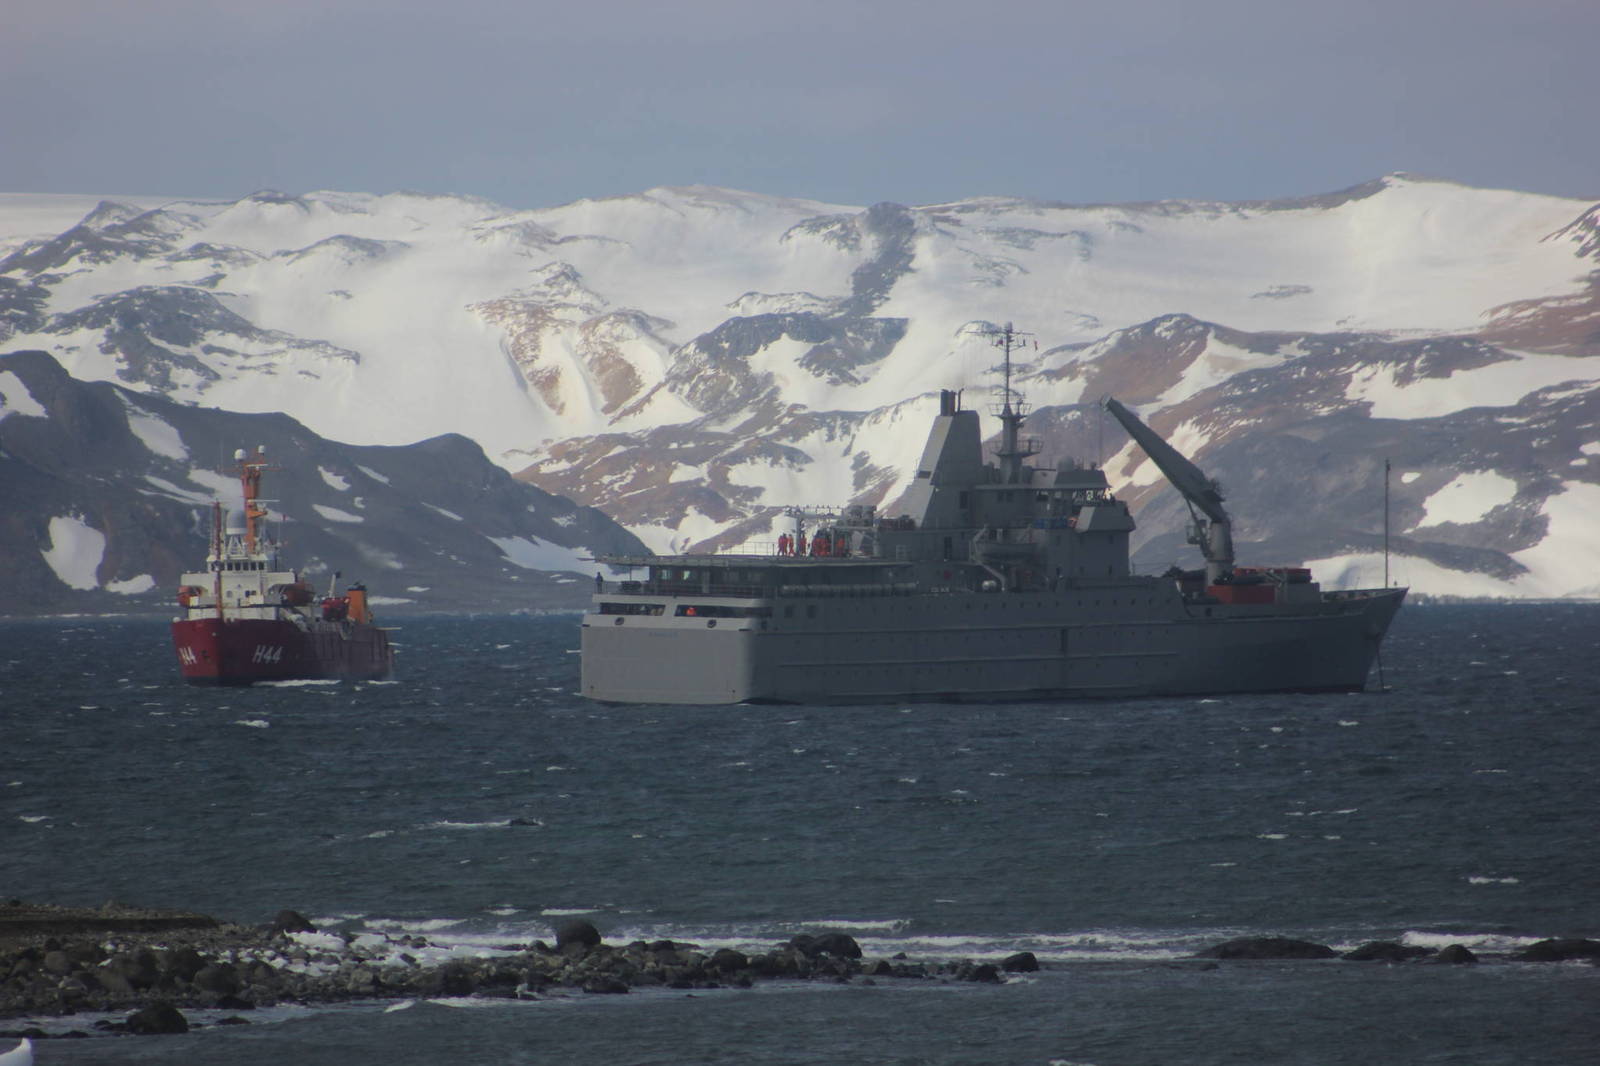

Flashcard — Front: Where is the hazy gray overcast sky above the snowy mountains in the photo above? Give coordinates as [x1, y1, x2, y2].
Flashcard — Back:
[0, 0, 1600, 206]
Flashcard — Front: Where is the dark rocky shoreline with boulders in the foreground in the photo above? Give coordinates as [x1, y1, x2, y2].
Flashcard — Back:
[0, 901, 1600, 1039]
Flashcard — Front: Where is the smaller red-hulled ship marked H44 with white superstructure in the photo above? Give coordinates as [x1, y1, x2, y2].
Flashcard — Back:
[173, 448, 394, 685]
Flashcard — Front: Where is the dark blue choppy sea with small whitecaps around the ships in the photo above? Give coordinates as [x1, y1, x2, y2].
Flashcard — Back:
[0, 605, 1600, 1066]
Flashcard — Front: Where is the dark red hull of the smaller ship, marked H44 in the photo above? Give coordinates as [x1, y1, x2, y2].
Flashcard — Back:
[173, 618, 394, 685]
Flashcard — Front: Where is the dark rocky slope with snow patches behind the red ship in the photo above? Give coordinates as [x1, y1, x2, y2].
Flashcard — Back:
[0, 351, 642, 615]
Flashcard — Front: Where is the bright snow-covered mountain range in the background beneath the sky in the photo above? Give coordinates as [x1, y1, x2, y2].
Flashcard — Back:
[0, 174, 1600, 597]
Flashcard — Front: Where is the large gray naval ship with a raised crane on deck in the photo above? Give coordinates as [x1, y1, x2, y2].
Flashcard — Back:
[582, 327, 1406, 704]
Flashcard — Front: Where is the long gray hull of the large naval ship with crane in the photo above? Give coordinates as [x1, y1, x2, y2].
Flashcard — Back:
[582, 583, 1405, 704]
